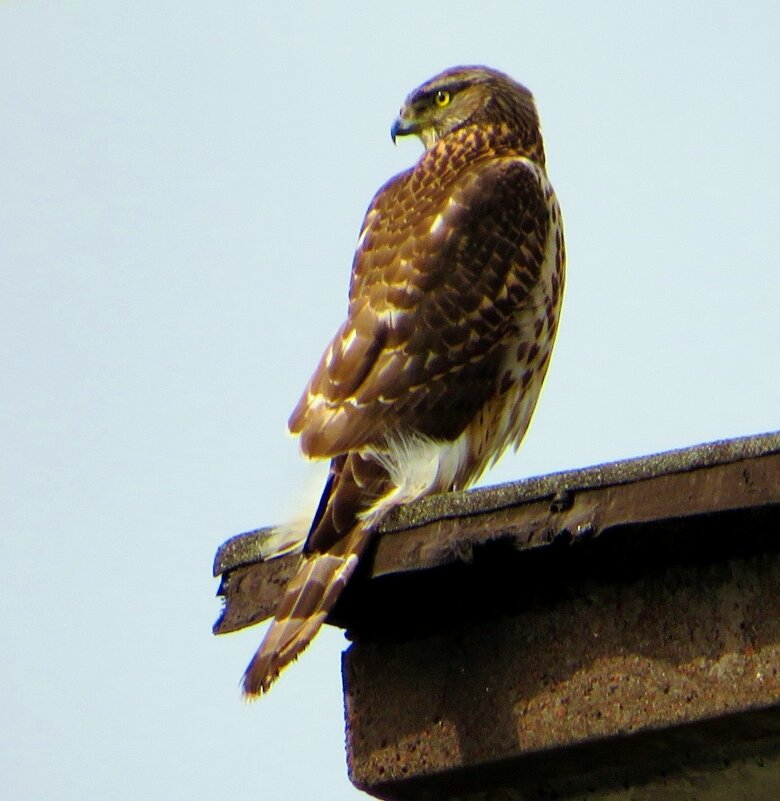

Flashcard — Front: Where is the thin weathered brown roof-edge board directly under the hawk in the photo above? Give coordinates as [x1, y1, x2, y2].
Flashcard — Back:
[213, 432, 780, 634]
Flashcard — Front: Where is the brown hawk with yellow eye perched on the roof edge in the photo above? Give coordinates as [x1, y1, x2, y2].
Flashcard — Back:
[243, 67, 565, 697]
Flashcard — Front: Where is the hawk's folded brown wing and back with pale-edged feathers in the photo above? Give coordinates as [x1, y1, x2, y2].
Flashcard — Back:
[289, 151, 550, 457]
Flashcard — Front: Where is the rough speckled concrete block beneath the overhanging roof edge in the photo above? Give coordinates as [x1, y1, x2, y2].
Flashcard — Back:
[345, 555, 780, 799]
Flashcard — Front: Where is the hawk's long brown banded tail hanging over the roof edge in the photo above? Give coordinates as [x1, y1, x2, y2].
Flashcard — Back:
[243, 453, 389, 698]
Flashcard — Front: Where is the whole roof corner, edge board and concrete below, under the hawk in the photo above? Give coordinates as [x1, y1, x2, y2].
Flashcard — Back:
[215, 434, 780, 801]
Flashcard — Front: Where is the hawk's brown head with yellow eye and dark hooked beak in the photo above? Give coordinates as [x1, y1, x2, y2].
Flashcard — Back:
[390, 67, 539, 154]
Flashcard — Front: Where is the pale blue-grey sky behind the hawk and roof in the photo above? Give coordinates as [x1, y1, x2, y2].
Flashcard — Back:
[0, 0, 780, 801]
